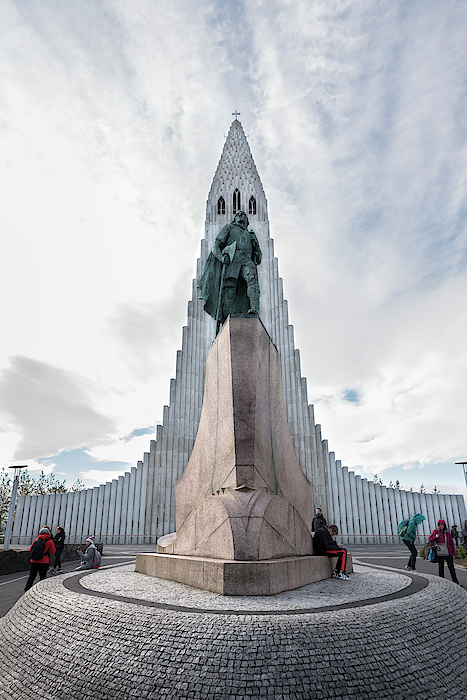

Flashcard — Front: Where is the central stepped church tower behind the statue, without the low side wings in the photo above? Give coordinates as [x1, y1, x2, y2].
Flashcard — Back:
[145, 119, 329, 537]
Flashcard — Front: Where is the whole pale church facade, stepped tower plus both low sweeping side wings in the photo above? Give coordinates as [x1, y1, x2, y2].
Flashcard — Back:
[12, 119, 467, 544]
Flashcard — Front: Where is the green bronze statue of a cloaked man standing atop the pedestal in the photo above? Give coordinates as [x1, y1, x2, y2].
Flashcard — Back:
[198, 211, 262, 332]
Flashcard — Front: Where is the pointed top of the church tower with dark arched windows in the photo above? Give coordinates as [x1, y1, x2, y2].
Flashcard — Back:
[206, 115, 268, 225]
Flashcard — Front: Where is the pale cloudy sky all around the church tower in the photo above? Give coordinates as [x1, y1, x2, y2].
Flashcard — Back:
[0, 0, 467, 496]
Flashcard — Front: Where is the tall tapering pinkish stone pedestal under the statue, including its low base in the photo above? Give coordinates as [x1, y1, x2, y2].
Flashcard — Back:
[138, 318, 330, 595]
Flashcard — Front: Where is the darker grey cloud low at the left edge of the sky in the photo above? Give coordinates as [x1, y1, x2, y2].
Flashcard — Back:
[0, 356, 115, 460]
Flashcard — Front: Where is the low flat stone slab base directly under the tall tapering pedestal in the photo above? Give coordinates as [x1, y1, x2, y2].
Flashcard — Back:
[136, 554, 353, 595]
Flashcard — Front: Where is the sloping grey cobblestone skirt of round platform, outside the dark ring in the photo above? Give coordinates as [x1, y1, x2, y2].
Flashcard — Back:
[0, 571, 467, 700]
